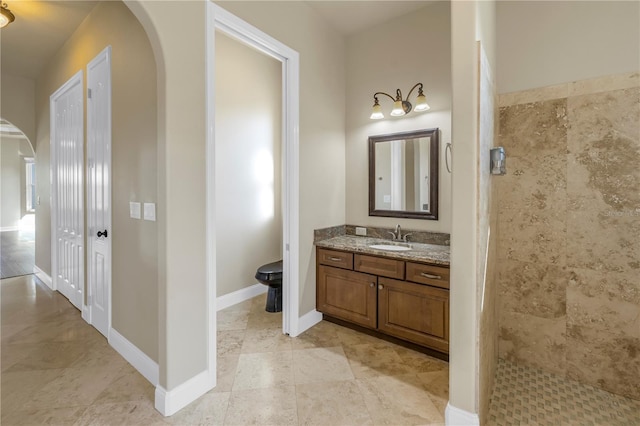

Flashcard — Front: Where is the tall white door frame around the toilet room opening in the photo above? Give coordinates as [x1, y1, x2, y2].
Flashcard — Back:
[206, 2, 300, 377]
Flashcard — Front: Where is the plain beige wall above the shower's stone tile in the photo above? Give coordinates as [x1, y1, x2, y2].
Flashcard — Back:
[496, 1, 640, 93]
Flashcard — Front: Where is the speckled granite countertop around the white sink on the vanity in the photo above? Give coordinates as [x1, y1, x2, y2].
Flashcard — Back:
[315, 235, 450, 266]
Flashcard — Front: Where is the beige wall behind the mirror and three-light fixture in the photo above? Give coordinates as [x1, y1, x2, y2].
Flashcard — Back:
[346, 2, 451, 232]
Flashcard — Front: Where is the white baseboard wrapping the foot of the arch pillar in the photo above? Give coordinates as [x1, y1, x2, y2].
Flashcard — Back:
[155, 371, 215, 416]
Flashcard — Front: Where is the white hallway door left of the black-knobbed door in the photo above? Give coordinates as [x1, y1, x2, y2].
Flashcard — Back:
[49, 71, 84, 309]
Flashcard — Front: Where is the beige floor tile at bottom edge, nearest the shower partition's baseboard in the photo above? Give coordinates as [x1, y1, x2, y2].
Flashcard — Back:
[357, 374, 444, 425]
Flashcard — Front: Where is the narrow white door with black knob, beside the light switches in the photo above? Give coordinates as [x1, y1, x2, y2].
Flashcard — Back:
[87, 46, 112, 338]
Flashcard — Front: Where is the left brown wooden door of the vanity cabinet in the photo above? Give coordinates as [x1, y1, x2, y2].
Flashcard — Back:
[317, 265, 377, 329]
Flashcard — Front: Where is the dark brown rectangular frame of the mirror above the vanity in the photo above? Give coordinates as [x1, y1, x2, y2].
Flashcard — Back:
[369, 127, 440, 220]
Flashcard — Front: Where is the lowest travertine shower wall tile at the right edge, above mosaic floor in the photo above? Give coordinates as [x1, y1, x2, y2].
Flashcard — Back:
[567, 325, 640, 400]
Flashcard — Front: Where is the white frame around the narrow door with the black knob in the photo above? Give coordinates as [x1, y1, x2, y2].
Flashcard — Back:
[82, 45, 113, 334]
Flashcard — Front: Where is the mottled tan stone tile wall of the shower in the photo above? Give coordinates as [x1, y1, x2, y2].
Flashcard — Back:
[497, 73, 640, 400]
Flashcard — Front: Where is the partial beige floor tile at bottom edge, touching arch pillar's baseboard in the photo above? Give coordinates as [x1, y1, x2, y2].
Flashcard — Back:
[164, 392, 231, 426]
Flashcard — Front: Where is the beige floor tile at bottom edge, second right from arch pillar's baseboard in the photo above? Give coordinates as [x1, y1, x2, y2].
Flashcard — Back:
[224, 386, 298, 426]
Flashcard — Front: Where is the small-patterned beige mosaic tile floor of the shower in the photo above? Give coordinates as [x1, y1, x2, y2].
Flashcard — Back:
[487, 359, 640, 426]
